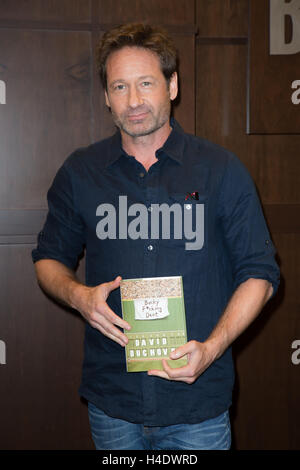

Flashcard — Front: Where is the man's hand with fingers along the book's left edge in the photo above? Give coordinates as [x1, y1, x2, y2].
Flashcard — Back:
[75, 276, 131, 346]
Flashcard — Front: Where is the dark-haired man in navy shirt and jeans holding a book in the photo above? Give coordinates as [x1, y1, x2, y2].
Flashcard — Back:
[33, 24, 279, 449]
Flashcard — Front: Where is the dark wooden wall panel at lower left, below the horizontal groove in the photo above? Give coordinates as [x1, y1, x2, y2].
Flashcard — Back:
[0, 245, 92, 450]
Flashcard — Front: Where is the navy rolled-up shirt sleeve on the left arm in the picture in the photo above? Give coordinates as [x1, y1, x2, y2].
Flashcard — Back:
[32, 160, 85, 269]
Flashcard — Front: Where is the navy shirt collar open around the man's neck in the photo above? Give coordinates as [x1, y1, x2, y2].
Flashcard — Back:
[106, 117, 184, 166]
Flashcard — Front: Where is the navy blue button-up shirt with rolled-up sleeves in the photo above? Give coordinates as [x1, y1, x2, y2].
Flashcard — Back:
[32, 120, 279, 426]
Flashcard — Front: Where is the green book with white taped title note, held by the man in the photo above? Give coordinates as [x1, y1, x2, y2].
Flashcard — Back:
[120, 276, 187, 372]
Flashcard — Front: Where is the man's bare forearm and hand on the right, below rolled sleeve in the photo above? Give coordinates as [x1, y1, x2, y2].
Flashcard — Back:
[148, 278, 273, 384]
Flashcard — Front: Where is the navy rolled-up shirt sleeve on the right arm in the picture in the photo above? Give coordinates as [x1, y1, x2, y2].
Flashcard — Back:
[219, 154, 280, 296]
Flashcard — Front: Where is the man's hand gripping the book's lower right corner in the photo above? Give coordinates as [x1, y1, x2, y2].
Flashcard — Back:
[148, 341, 214, 384]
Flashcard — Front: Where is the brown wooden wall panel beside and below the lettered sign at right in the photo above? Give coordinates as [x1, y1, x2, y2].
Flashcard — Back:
[196, 41, 300, 204]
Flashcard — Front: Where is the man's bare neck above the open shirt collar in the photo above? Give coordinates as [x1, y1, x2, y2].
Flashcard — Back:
[121, 121, 172, 171]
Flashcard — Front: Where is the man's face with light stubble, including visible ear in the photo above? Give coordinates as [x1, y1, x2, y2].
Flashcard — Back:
[105, 47, 177, 137]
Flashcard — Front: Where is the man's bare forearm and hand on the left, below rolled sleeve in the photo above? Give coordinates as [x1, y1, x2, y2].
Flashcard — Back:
[35, 259, 130, 346]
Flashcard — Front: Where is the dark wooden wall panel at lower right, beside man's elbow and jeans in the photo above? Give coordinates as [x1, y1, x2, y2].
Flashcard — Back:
[232, 233, 300, 450]
